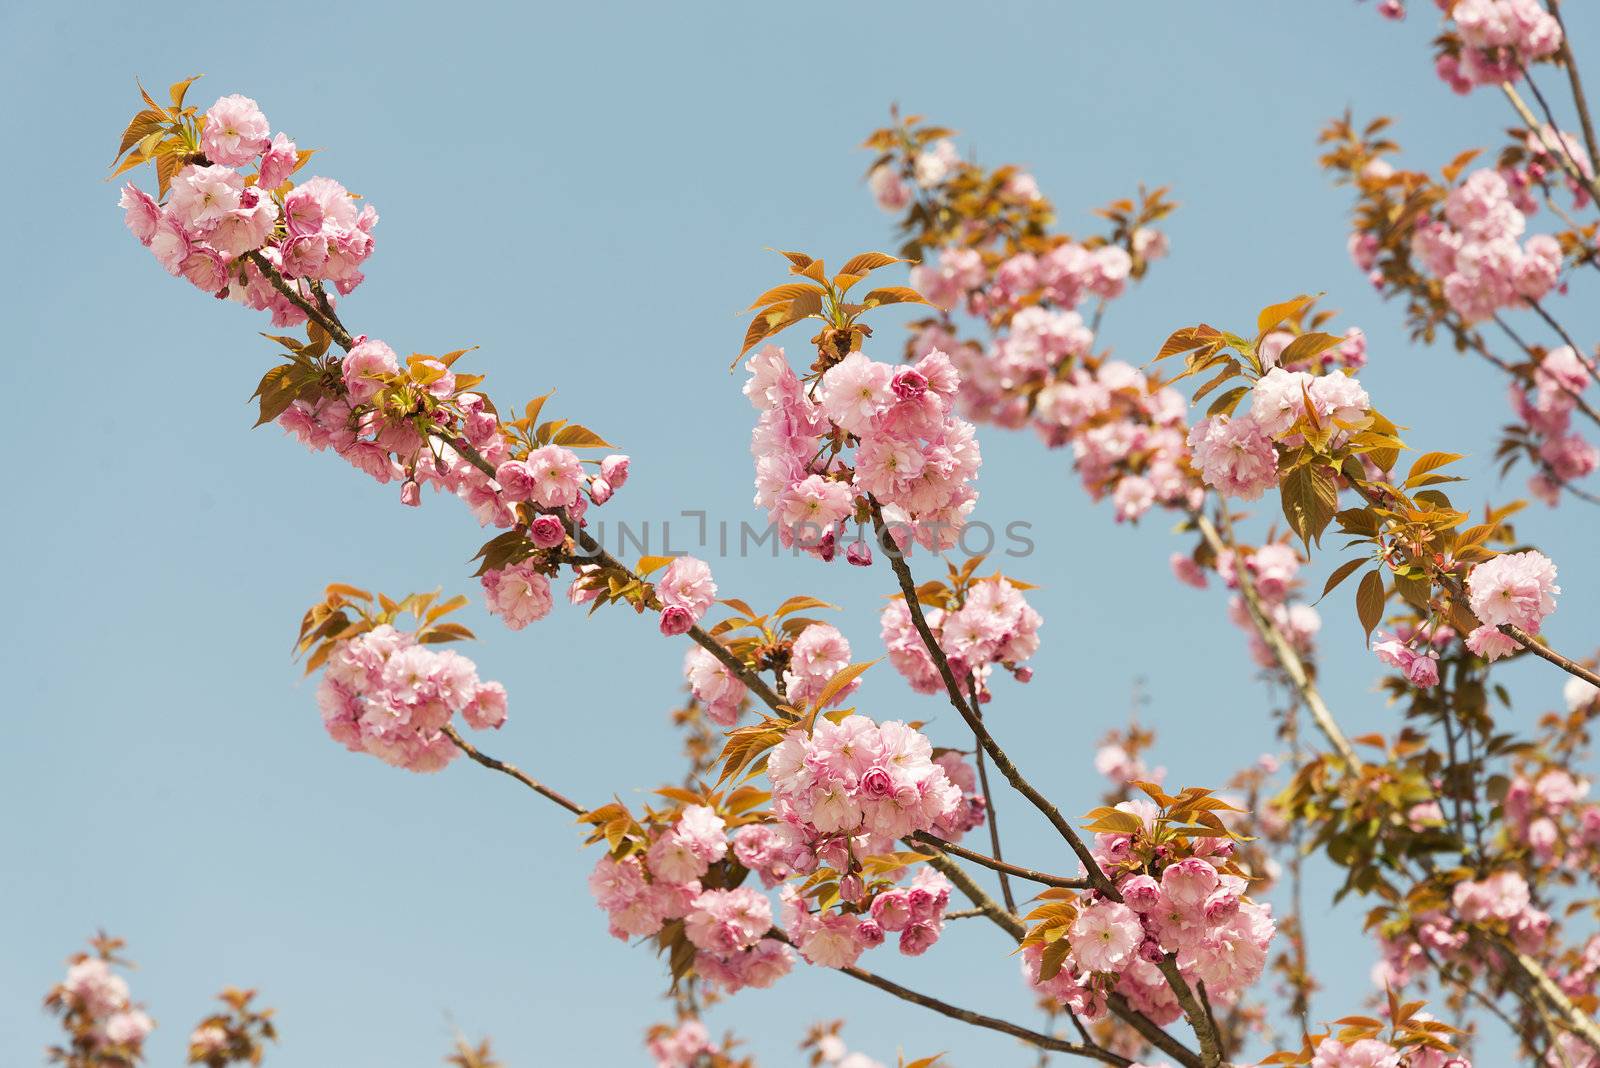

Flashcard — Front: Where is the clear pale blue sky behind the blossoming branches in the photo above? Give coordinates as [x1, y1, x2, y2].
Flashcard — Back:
[0, 0, 1600, 1068]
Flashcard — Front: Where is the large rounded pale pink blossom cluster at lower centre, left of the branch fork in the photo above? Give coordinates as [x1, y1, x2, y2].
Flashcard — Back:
[766, 715, 962, 843]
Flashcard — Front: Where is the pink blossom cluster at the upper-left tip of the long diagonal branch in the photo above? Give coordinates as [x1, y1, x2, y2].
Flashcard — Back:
[120, 94, 378, 316]
